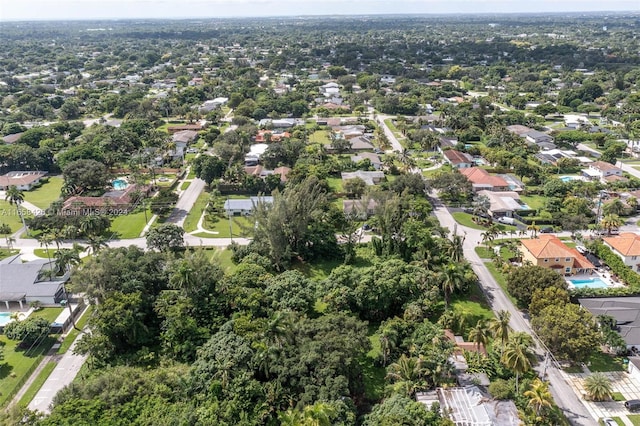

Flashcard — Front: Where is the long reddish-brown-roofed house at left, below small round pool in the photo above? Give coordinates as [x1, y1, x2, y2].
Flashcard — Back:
[62, 185, 151, 216]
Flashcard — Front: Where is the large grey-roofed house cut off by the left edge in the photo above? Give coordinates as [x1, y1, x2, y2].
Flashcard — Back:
[0, 255, 69, 310]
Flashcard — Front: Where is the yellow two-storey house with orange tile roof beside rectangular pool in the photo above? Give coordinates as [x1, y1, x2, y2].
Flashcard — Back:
[520, 234, 595, 275]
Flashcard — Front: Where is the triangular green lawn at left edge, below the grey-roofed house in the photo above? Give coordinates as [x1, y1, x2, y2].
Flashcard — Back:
[0, 335, 56, 407]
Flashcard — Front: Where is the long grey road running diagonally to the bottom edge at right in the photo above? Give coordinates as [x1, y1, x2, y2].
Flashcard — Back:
[434, 198, 598, 426]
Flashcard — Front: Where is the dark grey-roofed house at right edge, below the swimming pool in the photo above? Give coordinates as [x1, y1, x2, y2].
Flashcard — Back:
[578, 297, 640, 353]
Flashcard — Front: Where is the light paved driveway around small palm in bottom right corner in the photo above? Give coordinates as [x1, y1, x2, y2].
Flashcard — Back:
[562, 368, 640, 426]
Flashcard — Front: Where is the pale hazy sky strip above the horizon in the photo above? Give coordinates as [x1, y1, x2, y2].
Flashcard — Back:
[0, 0, 640, 21]
